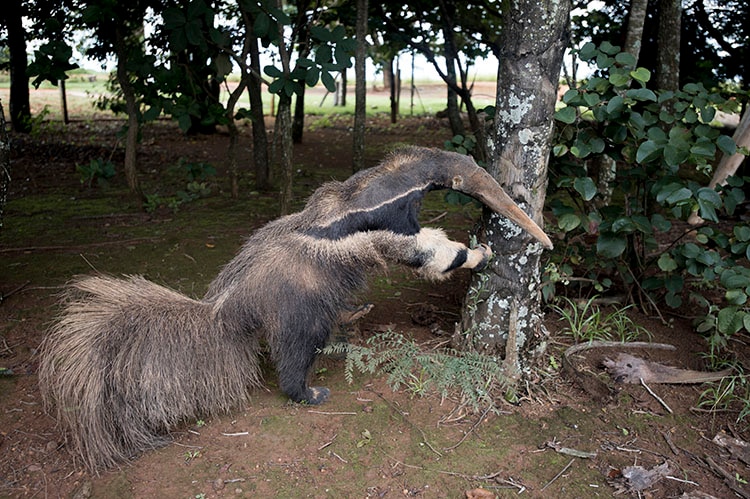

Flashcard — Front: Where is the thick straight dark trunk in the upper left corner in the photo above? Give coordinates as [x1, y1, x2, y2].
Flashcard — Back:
[4, 0, 31, 133]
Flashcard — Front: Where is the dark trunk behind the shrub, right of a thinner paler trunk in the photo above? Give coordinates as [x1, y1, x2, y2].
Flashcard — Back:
[656, 0, 682, 91]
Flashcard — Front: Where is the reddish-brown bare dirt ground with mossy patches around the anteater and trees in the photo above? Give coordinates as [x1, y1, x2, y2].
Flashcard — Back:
[0, 110, 750, 499]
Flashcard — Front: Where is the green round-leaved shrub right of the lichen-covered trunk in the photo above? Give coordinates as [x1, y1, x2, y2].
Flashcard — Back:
[544, 43, 750, 352]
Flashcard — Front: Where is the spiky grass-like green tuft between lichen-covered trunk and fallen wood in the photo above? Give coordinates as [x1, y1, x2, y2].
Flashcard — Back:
[552, 296, 651, 343]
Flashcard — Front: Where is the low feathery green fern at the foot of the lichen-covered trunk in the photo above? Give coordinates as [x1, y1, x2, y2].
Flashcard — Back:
[323, 331, 508, 410]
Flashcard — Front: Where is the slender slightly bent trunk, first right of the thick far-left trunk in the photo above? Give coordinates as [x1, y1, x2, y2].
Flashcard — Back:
[115, 29, 142, 197]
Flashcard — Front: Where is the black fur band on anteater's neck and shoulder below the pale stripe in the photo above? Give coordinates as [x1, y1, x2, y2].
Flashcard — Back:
[308, 189, 427, 240]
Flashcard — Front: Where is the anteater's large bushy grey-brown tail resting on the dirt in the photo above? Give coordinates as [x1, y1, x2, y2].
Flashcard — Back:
[39, 276, 261, 470]
